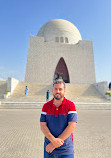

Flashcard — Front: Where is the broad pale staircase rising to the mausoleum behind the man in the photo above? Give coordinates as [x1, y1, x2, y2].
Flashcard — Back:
[1, 82, 107, 102]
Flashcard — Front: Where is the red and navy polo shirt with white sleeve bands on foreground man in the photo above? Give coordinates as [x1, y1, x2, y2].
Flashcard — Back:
[40, 97, 77, 155]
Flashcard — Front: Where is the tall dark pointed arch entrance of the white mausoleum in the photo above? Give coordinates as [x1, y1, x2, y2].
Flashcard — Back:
[54, 57, 70, 83]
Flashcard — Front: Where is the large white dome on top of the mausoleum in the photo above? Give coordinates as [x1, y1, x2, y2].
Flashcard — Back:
[37, 19, 82, 44]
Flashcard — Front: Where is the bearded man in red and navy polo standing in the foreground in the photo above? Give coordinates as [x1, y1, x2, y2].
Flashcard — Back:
[40, 79, 77, 158]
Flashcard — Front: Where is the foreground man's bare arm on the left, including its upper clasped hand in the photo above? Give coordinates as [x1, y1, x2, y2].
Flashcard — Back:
[40, 122, 64, 148]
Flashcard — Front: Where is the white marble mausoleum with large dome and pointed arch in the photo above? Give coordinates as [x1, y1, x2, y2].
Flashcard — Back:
[25, 19, 96, 84]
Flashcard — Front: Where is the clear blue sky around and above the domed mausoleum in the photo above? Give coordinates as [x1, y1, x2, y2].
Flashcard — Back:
[0, 0, 111, 82]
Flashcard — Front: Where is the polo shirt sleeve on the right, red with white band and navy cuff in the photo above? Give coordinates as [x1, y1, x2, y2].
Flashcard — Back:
[68, 102, 77, 122]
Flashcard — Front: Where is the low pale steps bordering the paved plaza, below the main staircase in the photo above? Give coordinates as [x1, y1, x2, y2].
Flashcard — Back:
[0, 102, 111, 110]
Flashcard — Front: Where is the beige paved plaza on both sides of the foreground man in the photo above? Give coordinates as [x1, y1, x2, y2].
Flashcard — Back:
[0, 109, 111, 158]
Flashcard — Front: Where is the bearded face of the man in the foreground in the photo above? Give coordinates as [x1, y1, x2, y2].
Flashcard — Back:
[52, 83, 65, 100]
